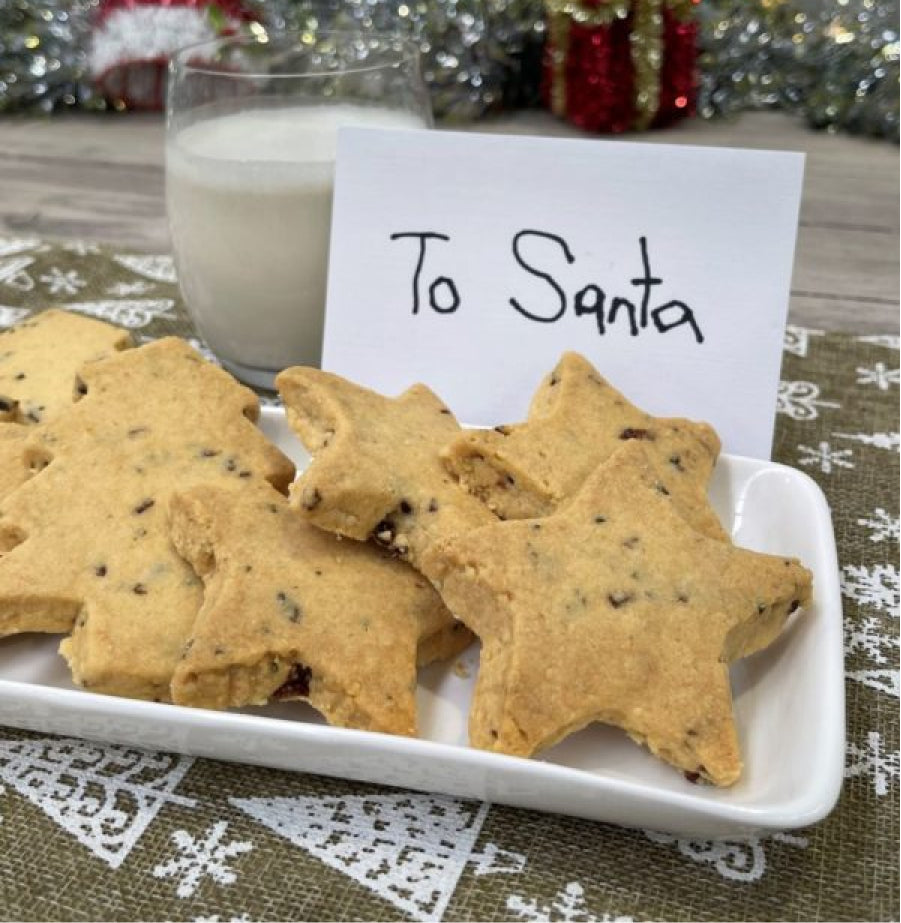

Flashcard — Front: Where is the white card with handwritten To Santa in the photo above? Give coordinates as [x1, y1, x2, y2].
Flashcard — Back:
[322, 128, 804, 458]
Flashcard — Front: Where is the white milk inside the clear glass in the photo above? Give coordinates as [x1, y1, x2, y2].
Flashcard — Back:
[166, 104, 424, 384]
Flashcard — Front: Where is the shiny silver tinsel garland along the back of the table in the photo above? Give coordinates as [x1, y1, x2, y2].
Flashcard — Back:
[0, 0, 899, 140]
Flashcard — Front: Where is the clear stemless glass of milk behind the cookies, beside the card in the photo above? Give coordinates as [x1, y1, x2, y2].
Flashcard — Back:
[166, 32, 432, 387]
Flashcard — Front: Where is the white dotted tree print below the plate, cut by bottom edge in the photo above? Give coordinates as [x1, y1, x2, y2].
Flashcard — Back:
[231, 792, 496, 920]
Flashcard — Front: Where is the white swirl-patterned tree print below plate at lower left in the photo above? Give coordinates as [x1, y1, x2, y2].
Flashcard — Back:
[0, 738, 195, 869]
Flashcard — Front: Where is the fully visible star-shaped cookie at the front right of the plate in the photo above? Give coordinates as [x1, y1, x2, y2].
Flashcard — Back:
[427, 441, 811, 785]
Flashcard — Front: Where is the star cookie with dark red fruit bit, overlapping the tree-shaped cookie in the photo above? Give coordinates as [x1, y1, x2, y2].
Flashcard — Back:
[169, 485, 472, 735]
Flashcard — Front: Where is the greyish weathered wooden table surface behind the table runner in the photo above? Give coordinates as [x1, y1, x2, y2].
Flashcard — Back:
[0, 111, 899, 333]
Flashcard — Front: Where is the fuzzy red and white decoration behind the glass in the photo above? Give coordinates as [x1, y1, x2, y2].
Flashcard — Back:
[89, 0, 252, 109]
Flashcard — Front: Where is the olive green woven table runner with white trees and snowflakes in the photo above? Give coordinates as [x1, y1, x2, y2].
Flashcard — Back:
[0, 238, 899, 923]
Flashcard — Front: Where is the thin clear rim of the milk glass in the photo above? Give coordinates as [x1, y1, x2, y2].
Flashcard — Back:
[169, 29, 421, 80]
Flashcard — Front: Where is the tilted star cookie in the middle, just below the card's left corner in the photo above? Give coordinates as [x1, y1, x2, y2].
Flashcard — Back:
[276, 367, 495, 568]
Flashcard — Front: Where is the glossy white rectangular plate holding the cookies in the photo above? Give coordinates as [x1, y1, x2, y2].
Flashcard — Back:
[0, 408, 845, 837]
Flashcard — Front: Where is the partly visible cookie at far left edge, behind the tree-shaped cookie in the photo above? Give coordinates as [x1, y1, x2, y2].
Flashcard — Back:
[0, 309, 132, 498]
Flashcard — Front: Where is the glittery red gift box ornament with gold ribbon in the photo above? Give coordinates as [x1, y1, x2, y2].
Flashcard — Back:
[543, 0, 698, 132]
